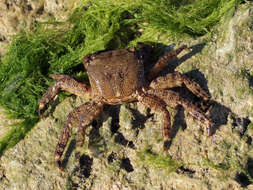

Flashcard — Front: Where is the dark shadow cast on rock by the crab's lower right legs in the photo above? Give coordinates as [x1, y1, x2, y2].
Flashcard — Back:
[168, 70, 250, 140]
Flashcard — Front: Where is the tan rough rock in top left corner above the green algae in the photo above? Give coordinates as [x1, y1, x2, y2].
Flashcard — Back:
[0, 0, 81, 55]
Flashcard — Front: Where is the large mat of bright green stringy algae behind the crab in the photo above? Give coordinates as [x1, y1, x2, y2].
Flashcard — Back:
[0, 0, 242, 154]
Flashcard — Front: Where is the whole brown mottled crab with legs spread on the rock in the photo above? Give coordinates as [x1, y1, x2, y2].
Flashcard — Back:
[38, 45, 212, 170]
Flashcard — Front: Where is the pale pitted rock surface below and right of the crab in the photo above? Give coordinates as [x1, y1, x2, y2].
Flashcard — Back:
[0, 1, 253, 190]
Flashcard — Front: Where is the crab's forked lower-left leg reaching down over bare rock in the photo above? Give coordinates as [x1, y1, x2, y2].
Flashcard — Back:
[54, 101, 103, 170]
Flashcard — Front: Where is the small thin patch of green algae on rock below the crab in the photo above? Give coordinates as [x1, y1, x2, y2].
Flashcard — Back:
[138, 150, 183, 173]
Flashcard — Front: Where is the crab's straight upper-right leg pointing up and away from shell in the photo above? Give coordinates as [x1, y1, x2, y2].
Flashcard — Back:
[147, 45, 187, 81]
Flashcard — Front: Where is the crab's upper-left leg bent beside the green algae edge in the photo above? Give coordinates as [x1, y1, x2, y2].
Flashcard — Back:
[39, 75, 91, 117]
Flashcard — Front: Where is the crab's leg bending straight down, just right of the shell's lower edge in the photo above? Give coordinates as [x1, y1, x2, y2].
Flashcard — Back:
[138, 93, 171, 151]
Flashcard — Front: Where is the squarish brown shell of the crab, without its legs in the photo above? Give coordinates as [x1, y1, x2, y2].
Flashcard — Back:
[83, 49, 145, 104]
